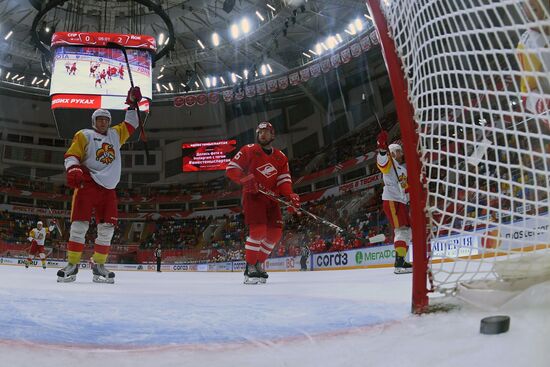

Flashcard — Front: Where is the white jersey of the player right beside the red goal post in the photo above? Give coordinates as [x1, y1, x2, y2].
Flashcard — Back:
[376, 152, 409, 204]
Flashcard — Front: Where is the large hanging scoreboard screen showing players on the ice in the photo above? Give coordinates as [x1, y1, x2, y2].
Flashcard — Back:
[50, 32, 156, 110]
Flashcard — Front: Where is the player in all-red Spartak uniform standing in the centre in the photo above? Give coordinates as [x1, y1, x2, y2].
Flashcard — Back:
[226, 122, 300, 284]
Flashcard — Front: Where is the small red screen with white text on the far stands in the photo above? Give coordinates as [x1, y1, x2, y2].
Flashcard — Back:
[181, 140, 237, 172]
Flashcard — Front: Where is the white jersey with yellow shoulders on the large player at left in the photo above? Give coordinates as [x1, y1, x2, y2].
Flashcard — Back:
[65, 110, 138, 189]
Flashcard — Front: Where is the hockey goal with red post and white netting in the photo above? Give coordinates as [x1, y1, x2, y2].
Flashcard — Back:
[367, 0, 550, 311]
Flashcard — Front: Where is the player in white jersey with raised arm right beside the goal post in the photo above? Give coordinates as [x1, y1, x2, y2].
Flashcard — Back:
[376, 131, 412, 274]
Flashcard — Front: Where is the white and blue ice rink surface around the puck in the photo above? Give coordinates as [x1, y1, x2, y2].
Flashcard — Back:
[0, 266, 550, 367]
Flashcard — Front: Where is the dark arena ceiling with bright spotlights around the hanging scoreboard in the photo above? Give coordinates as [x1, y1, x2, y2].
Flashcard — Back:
[0, 0, 374, 95]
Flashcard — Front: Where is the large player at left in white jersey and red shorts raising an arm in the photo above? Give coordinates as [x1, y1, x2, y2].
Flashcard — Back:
[57, 87, 141, 283]
